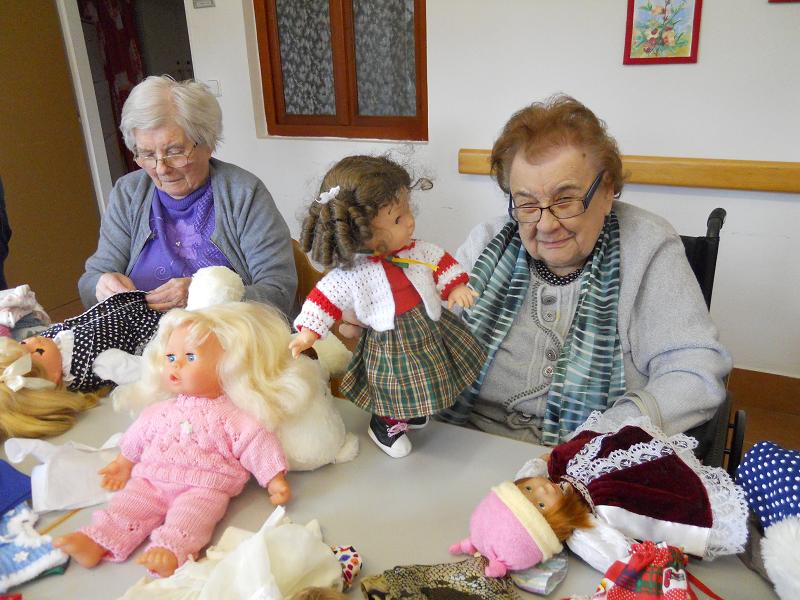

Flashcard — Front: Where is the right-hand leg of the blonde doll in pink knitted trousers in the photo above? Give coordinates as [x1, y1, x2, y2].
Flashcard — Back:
[144, 487, 230, 576]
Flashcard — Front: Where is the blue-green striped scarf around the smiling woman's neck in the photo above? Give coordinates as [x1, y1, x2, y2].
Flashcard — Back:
[440, 211, 625, 445]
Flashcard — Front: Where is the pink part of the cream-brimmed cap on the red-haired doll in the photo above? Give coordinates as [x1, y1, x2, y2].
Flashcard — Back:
[450, 492, 543, 577]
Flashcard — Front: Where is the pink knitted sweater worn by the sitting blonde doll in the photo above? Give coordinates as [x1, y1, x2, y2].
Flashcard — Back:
[120, 395, 287, 496]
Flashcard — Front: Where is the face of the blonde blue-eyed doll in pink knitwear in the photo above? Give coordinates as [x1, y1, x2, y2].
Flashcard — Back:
[163, 326, 223, 398]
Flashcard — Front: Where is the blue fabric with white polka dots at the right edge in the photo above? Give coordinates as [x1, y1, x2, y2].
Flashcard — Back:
[736, 442, 800, 528]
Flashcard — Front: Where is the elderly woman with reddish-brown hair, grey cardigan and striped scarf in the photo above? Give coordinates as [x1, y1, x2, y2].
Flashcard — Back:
[443, 96, 731, 445]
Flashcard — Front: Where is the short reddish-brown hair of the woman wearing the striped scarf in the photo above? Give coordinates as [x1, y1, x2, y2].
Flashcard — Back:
[491, 94, 625, 196]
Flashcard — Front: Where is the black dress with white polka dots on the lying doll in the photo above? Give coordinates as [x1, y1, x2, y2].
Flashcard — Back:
[39, 292, 164, 392]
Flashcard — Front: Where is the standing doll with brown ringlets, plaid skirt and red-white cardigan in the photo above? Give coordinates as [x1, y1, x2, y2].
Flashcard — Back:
[290, 156, 484, 458]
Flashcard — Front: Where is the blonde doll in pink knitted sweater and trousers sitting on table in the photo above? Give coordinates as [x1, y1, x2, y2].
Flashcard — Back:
[54, 302, 291, 576]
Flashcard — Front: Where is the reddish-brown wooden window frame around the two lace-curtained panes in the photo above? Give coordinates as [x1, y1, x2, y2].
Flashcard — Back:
[253, 0, 428, 141]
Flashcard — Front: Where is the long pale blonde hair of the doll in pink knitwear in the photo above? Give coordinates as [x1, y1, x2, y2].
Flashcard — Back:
[112, 302, 323, 431]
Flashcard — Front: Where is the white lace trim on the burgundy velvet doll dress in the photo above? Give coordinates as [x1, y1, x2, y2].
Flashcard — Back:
[567, 411, 747, 560]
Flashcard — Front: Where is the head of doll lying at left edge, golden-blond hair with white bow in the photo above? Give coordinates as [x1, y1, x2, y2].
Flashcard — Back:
[0, 337, 97, 438]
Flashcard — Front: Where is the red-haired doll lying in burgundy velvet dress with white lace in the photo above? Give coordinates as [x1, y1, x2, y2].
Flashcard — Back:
[517, 412, 747, 560]
